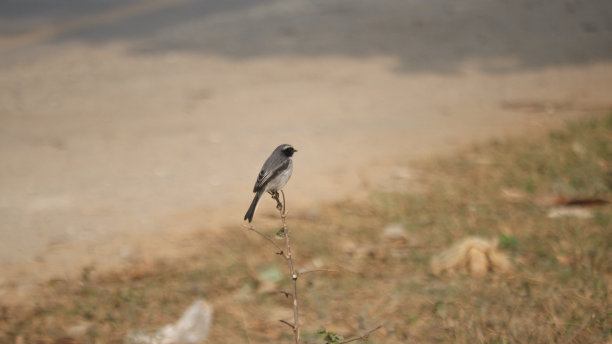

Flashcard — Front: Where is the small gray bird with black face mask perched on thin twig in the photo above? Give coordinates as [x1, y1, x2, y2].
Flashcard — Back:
[244, 144, 297, 222]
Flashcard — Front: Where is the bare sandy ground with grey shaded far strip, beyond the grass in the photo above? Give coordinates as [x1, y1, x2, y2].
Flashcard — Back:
[0, 0, 612, 295]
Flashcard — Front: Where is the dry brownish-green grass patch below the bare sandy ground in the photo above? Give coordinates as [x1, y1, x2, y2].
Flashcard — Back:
[0, 115, 612, 343]
